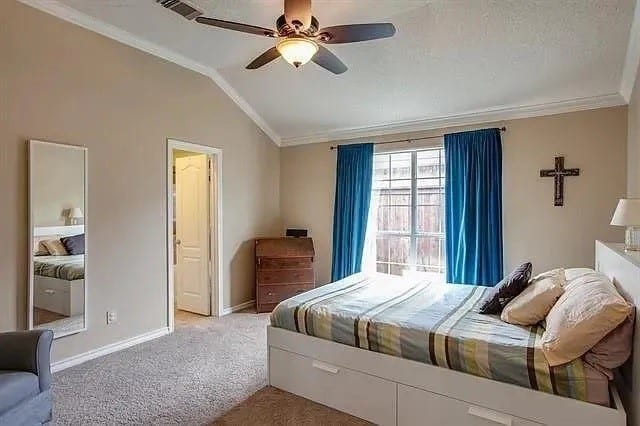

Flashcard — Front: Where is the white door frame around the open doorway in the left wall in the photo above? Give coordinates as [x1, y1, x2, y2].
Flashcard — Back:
[166, 138, 224, 332]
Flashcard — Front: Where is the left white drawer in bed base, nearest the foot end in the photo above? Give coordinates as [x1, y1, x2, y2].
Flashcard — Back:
[269, 347, 396, 425]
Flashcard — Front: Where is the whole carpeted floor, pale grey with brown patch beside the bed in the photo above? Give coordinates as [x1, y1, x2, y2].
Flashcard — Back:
[52, 313, 363, 425]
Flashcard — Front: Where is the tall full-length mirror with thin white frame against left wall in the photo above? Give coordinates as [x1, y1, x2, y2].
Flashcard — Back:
[29, 140, 87, 338]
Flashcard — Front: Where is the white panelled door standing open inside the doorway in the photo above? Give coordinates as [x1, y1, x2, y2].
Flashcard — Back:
[175, 154, 211, 315]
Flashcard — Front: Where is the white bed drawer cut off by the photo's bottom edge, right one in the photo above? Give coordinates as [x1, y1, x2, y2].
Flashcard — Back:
[398, 385, 542, 426]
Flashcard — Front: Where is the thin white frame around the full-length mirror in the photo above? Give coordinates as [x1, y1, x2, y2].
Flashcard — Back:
[27, 139, 89, 339]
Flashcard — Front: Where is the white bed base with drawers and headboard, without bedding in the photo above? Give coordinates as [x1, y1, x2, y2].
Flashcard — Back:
[267, 242, 640, 426]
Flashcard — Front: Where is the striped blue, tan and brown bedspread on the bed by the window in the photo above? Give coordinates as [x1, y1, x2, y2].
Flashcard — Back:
[271, 274, 609, 405]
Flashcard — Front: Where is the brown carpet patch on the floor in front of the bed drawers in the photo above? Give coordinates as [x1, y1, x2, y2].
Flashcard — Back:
[213, 386, 371, 426]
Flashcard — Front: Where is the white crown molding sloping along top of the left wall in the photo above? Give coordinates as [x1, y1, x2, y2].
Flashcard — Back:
[18, 0, 281, 146]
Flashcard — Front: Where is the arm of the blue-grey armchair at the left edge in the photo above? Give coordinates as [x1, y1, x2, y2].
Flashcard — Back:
[0, 330, 53, 392]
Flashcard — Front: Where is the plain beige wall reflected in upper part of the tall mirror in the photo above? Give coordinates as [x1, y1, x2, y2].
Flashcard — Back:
[30, 142, 84, 226]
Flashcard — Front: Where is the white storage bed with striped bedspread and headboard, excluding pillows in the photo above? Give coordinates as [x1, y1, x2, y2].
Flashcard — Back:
[268, 243, 640, 426]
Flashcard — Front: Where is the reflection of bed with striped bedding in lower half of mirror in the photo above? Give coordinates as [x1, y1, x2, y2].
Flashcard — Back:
[33, 225, 84, 332]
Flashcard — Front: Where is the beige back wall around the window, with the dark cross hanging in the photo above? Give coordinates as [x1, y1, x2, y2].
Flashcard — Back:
[280, 107, 627, 283]
